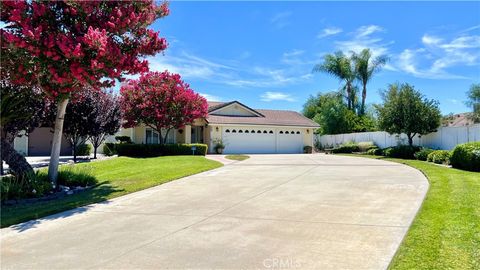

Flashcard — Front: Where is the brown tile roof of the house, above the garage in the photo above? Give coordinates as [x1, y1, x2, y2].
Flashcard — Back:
[206, 102, 319, 127]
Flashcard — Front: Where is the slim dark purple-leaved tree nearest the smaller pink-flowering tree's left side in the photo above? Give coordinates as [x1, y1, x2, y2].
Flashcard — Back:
[87, 92, 122, 158]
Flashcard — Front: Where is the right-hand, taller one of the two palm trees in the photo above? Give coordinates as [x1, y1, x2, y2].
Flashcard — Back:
[352, 49, 388, 115]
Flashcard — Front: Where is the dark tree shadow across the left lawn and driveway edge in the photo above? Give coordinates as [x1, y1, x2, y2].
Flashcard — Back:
[1, 182, 124, 232]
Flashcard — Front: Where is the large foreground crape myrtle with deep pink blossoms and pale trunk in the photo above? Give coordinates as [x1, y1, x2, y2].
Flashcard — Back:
[0, 0, 169, 186]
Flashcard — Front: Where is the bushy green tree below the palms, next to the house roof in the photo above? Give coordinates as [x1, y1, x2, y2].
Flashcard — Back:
[303, 92, 376, 134]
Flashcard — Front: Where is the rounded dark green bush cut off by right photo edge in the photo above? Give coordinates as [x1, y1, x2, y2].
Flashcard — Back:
[450, 142, 480, 172]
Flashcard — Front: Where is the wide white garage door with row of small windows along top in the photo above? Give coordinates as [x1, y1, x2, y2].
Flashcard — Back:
[222, 127, 303, 154]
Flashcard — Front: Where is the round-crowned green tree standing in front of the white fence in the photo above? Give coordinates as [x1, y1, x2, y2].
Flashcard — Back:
[377, 83, 441, 146]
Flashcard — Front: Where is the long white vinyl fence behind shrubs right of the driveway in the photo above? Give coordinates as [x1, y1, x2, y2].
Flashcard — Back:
[315, 124, 480, 150]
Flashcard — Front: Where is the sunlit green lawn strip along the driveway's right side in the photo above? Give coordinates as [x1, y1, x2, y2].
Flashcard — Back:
[344, 155, 480, 270]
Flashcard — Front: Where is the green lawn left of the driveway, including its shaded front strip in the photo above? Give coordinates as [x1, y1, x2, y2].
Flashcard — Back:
[1, 156, 222, 227]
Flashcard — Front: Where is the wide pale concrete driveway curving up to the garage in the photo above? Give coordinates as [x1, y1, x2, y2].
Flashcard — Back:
[1, 154, 428, 269]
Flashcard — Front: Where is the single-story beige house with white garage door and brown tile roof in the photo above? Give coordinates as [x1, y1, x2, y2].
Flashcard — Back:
[115, 101, 319, 154]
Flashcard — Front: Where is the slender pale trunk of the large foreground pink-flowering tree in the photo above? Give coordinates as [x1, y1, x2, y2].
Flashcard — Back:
[48, 98, 68, 188]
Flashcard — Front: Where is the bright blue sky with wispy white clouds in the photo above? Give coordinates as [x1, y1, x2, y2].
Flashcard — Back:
[149, 1, 480, 113]
